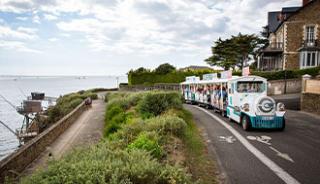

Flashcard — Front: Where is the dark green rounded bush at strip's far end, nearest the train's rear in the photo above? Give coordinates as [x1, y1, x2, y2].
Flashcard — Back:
[139, 92, 182, 117]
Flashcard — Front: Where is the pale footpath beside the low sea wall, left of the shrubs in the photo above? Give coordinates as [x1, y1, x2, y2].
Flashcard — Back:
[23, 94, 105, 175]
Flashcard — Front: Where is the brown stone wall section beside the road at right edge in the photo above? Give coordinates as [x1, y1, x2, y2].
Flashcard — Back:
[301, 93, 320, 115]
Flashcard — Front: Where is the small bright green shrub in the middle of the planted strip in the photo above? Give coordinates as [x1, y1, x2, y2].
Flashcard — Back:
[128, 132, 163, 158]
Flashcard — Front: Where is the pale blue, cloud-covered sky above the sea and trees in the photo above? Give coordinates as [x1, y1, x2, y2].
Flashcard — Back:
[0, 0, 302, 76]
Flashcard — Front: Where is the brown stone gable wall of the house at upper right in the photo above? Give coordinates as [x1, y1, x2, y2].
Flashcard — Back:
[277, 0, 320, 69]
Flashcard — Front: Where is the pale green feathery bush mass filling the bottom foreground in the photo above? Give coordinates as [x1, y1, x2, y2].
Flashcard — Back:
[21, 144, 192, 184]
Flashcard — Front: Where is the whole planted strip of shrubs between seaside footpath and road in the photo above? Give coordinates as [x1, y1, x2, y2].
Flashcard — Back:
[21, 91, 216, 184]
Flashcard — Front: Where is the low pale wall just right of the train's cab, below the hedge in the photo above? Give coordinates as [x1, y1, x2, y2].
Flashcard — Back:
[268, 79, 302, 95]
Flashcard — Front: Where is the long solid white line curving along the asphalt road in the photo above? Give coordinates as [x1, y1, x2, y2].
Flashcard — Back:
[194, 106, 300, 184]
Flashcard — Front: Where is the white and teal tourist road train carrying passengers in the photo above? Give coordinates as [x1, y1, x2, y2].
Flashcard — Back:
[180, 74, 285, 131]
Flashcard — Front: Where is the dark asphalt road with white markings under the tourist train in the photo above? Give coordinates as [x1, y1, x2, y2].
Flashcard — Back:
[185, 105, 320, 184]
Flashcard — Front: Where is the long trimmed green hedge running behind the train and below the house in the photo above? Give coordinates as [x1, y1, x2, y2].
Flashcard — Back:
[128, 67, 320, 85]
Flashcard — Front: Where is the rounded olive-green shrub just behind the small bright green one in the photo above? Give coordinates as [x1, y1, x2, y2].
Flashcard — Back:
[146, 115, 187, 136]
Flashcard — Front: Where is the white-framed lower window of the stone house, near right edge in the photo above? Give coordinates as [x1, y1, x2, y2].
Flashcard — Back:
[300, 51, 320, 68]
